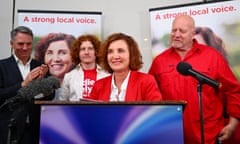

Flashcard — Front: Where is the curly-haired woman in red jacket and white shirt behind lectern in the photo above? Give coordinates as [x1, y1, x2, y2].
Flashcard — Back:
[90, 33, 162, 101]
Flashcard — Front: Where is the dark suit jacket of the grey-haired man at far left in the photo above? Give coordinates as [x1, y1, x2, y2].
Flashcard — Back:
[0, 56, 41, 143]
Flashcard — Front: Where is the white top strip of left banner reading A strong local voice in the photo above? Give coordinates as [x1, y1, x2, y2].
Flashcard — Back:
[18, 10, 102, 51]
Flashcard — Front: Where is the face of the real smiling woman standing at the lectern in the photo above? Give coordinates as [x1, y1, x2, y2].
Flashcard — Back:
[107, 40, 130, 72]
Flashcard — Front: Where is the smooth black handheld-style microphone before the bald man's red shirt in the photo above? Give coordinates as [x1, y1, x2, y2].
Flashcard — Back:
[177, 62, 222, 88]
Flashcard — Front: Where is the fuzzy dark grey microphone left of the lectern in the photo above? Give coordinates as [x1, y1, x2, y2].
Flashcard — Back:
[4, 76, 60, 105]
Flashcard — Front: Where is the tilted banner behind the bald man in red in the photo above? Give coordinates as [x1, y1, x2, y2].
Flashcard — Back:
[149, 1, 240, 80]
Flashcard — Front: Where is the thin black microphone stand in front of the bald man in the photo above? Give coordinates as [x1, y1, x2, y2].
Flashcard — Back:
[197, 79, 205, 144]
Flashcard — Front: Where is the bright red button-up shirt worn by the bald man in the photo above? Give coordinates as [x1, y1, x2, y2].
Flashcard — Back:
[149, 41, 240, 144]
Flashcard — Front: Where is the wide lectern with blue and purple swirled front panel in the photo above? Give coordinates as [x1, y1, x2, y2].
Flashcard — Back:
[35, 101, 186, 144]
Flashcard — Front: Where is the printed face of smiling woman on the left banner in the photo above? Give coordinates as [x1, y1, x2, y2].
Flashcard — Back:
[44, 40, 73, 79]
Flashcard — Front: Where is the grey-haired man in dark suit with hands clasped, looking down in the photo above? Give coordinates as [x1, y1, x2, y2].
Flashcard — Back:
[0, 26, 48, 144]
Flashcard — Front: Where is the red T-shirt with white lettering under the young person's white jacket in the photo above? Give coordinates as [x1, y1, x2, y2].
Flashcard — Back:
[83, 69, 97, 98]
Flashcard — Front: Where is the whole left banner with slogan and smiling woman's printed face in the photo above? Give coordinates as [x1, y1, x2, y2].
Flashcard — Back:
[18, 10, 102, 81]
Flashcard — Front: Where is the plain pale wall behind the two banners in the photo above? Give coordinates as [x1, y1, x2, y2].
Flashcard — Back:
[0, 0, 202, 72]
